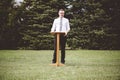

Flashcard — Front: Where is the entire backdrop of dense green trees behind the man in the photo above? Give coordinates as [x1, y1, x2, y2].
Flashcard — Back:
[0, 0, 120, 50]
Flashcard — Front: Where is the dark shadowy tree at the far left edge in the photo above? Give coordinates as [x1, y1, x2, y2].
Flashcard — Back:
[0, 0, 16, 49]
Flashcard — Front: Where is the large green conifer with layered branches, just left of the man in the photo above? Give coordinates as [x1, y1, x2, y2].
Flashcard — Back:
[21, 0, 65, 49]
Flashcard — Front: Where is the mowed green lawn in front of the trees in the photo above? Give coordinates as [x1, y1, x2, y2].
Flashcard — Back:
[0, 50, 120, 80]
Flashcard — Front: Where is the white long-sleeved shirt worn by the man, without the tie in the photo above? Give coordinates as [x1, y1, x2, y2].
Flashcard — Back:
[51, 17, 70, 34]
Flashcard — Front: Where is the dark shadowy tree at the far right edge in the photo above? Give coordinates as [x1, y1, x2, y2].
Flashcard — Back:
[101, 0, 120, 49]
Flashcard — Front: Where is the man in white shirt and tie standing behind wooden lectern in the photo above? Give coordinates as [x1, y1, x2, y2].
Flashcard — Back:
[51, 9, 70, 64]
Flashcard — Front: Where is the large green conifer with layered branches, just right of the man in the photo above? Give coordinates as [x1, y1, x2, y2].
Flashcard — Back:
[68, 0, 109, 49]
